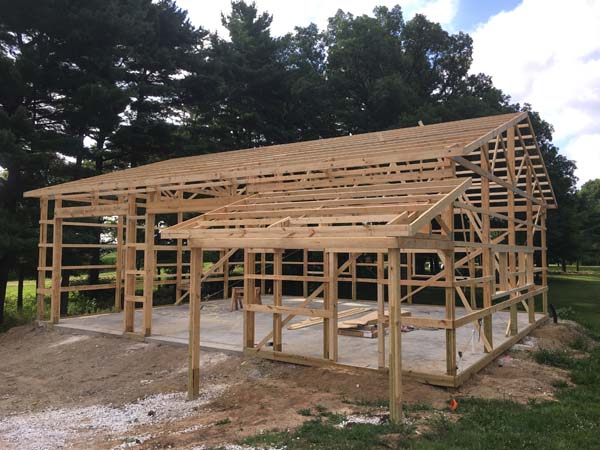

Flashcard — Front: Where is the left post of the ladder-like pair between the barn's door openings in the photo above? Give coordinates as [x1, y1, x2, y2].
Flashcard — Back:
[123, 194, 137, 333]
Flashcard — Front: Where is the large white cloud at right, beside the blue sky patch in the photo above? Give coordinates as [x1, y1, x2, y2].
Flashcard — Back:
[473, 0, 600, 184]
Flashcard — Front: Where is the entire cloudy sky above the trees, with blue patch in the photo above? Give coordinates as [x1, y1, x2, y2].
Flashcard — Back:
[177, 0, 600, 186]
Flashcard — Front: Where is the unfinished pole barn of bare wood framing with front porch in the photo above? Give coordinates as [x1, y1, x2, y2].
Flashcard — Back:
[27, 113, 556, 419]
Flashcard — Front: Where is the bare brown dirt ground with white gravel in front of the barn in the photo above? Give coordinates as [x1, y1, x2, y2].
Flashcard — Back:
[0, 324, 580, 450]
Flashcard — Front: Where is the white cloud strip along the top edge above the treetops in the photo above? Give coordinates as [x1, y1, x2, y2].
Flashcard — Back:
[177, 0, 459, 36]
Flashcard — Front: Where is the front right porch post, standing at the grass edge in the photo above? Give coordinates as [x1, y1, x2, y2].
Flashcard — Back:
[388, 248, 402, 423]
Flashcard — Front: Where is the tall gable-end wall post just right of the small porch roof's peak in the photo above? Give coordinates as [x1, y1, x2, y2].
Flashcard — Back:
[481, 143, 495, 352]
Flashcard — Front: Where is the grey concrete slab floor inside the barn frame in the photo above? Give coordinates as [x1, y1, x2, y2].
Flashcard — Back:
[56, 295, 542, 374]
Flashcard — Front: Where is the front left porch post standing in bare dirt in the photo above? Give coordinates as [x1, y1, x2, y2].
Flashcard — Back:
[188, 247, 204, 400]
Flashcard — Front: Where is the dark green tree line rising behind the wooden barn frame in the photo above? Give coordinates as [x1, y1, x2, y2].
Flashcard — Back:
[0, 0, 598, 323]
